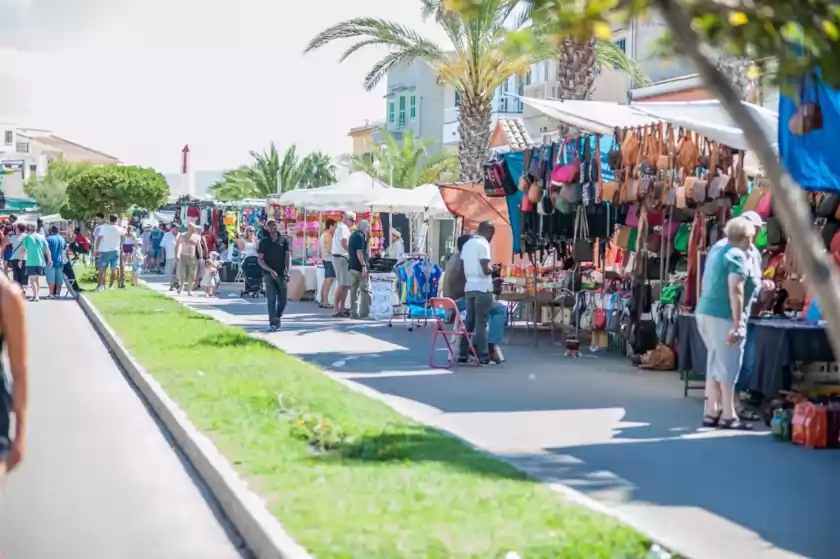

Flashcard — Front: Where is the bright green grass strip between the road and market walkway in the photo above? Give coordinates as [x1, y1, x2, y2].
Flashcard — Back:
[88, 288, 648, 559]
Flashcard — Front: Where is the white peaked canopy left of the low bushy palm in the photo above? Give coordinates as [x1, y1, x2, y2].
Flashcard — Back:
[280, 172, 391, 212]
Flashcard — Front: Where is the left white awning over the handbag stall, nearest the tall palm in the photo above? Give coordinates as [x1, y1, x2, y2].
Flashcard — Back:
[517, 96, 655, 136]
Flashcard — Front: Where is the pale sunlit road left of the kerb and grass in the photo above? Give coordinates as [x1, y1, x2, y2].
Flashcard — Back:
[0, 294, 248, 559]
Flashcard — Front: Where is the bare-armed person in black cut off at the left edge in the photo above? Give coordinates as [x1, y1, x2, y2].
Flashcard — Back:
[0, 270, 29, 487]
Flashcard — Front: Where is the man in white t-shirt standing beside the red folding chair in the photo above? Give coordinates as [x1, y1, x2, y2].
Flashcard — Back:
[458, 221, 506, 365]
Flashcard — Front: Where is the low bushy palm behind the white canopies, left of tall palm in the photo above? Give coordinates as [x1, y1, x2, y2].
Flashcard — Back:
[348, 129, 458, 188]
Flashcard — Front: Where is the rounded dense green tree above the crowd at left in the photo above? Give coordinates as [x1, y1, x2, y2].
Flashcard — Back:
[61, 165, 169, 221]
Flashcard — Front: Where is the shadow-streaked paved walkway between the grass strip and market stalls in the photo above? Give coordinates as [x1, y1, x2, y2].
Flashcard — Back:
[148, 280, 840, 559]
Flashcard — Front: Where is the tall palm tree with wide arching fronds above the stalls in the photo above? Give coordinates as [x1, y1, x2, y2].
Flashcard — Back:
[306, 0, 641, 180]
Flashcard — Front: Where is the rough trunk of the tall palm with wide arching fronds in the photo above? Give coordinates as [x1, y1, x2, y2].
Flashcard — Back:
[458, 92, 493, 181]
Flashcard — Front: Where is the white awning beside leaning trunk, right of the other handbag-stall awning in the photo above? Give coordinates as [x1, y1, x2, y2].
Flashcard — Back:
[630, 100, 779, 149]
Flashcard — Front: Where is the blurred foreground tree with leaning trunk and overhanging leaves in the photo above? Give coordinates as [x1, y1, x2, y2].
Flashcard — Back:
[496, 0, 840, 355]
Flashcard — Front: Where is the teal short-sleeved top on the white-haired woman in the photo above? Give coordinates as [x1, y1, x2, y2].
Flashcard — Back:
[696, 243, 761, 322]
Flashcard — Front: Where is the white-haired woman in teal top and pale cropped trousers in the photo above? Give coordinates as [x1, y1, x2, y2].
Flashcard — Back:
[695, 217, 761, 430]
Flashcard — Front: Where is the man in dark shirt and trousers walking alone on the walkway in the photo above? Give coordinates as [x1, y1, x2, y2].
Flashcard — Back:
[257, 219, 292, 332]
